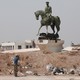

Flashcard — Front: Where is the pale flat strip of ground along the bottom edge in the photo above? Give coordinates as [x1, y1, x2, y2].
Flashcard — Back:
[0, 76, 80, 80]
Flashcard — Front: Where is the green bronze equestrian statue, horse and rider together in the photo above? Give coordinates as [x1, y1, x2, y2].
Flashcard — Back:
[34, 2, 61, 38]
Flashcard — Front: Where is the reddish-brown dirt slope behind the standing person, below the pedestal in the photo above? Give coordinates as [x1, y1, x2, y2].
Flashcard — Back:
[0, 51, 80, 75]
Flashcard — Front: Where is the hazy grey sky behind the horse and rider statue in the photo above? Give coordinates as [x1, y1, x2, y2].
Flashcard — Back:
[0, 0, 80, 46]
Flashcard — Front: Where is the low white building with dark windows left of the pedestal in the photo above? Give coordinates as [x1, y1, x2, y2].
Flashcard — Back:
[0, 40, 36, 51]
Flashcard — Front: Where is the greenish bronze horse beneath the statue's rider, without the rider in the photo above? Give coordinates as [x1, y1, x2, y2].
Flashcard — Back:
[35, 10, 61, 35]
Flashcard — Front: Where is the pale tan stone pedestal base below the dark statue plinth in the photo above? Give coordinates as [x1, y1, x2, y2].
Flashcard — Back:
[37, 39, 64, 52]
